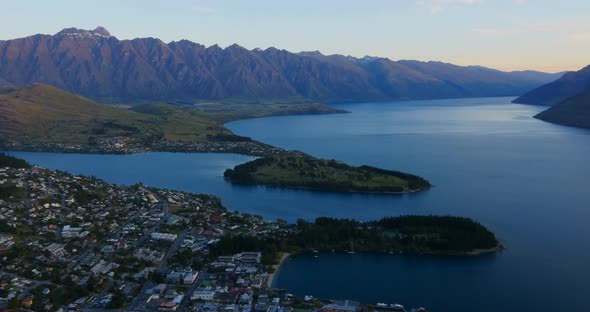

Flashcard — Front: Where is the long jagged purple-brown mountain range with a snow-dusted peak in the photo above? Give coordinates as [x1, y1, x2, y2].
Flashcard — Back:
[0, 27, 558, 103]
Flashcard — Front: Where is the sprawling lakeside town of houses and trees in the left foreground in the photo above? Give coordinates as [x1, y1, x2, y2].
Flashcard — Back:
[0, 156, 426, 312]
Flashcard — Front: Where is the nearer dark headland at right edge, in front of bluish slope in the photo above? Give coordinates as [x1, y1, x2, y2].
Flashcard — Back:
[535, 89, 590, 128]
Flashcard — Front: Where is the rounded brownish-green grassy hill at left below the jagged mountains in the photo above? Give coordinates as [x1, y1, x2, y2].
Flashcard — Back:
[0, 84, 156, 143]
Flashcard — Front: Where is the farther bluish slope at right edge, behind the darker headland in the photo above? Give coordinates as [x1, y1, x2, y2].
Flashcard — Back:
[514, 66, 590, 106]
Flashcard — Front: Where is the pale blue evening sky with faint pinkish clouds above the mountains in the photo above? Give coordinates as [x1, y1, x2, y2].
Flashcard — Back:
[0, 0, 590, 72]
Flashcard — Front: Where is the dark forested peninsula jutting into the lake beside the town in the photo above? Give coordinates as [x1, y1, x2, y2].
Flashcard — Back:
[211, 216, 502, 259]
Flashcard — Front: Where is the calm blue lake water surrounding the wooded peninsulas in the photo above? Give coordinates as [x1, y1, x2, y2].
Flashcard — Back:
[5, 98, 590, 311]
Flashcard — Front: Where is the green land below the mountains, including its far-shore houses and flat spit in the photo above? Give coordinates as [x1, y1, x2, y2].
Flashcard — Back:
[0, 84, 345, 155]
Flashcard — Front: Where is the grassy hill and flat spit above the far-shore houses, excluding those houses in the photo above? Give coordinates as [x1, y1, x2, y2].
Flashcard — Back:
[0, 84, 346, 144]
